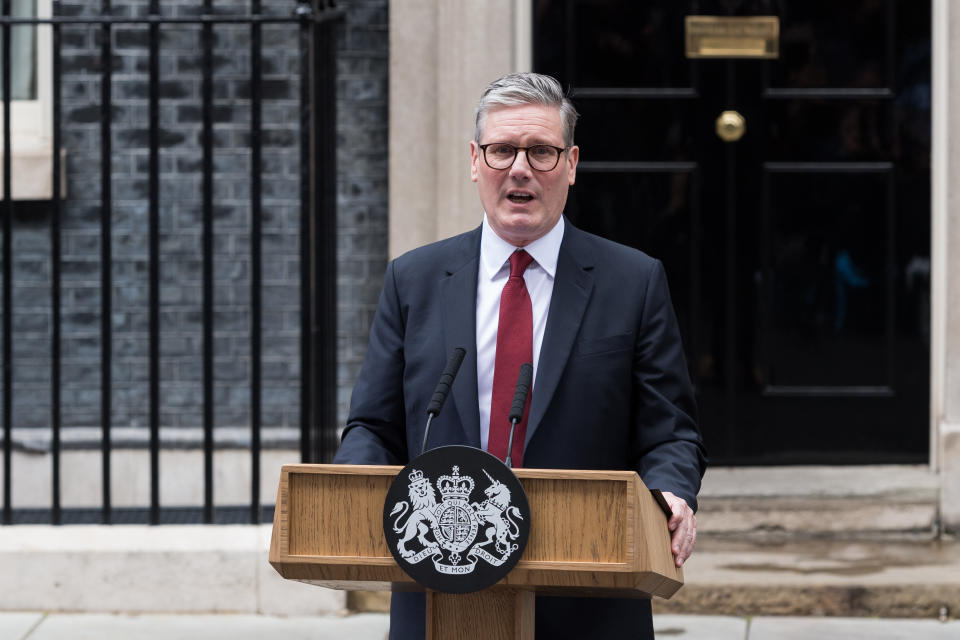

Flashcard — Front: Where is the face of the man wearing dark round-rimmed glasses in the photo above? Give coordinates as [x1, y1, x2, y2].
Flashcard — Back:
[470, 104, 580, 247]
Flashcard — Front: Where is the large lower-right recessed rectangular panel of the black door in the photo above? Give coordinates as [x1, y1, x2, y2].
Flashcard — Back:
[758, 171, 893, 388]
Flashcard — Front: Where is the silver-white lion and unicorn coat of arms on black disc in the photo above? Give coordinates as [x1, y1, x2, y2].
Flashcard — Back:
[389, 465, 524, 575]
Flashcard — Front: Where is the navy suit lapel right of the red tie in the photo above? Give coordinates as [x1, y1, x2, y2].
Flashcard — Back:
[526, 221, 593, 444]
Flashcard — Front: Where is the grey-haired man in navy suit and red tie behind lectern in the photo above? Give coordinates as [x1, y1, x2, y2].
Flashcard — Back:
[335, 73, 705, 639]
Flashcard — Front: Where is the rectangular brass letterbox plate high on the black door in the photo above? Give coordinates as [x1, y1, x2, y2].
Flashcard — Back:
[686, 16, 780, 58]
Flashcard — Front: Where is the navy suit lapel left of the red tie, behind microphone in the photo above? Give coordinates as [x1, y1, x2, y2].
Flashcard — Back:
[440, 229, 480, 448]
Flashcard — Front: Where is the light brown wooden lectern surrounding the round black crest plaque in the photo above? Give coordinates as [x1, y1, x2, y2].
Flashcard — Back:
[270, 464, 683, 640]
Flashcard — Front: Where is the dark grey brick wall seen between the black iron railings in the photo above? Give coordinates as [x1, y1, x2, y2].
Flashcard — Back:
[3, 0, 388, 448]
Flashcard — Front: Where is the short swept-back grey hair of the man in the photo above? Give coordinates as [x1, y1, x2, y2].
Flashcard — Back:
[473, 73, 579, 147]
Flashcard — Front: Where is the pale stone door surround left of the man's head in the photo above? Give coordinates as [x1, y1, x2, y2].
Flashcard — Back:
[390, 0, 532, 257]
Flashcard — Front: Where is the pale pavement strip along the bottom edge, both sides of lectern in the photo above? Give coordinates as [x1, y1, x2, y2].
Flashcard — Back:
[0, 611, 960, 640]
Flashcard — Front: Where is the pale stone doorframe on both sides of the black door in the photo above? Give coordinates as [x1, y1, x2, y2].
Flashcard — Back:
[389, 0, 960, 531]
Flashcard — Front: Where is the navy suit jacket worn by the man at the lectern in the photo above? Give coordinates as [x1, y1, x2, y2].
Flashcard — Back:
[335, 222, 706, 638]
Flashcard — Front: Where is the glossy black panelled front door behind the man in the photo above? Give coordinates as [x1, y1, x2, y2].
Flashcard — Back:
[534, 0, 930, 464]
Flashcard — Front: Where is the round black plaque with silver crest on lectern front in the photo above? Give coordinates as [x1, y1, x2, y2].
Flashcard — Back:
[383, 445, 530, 593]
